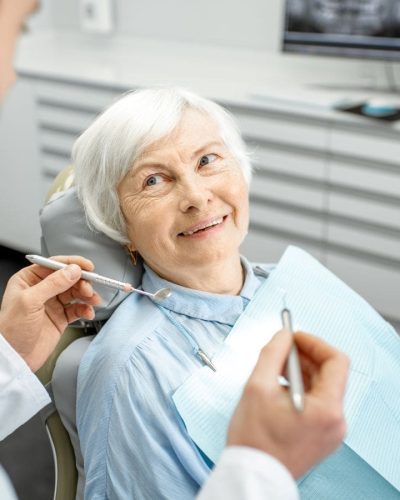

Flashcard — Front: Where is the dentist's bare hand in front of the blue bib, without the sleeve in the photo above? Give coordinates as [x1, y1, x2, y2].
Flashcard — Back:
[227, 330, 349, 478]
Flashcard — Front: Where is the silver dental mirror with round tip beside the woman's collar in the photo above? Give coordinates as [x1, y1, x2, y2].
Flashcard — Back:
[25, 255, 171, 301]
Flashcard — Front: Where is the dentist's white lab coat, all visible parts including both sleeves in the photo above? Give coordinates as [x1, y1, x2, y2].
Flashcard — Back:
[0, 334, 299, 500]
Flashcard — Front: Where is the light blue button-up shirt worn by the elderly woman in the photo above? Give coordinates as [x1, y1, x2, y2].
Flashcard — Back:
[77, 259, 264, 500]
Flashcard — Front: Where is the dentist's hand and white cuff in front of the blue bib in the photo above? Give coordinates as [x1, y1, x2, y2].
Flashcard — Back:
[198, 330, 348, 500]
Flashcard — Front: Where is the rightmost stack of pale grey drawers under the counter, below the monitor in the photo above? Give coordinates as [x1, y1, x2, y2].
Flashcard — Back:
[327, 148, 400, 321]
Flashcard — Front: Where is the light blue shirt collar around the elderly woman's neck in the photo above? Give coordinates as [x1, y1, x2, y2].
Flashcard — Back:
[142, 257, 261, 325]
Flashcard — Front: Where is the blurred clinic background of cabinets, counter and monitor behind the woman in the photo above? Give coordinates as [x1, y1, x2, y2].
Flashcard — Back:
[0, 0, 400, 500]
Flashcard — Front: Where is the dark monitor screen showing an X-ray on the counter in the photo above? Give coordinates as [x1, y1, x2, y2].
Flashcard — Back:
[283, 0, 400, 60]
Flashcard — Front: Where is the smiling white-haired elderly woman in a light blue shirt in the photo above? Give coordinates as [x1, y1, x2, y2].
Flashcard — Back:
[74, 89, 395, 500]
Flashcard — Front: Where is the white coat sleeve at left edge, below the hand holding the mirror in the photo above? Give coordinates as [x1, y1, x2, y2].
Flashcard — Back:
[0, 334, 50, 441]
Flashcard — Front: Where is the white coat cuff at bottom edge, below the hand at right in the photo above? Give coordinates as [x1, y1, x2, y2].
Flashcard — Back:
[197, 446, 300, 500]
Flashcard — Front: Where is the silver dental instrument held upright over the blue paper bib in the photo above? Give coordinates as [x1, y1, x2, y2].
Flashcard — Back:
[281, 307, 304, 412]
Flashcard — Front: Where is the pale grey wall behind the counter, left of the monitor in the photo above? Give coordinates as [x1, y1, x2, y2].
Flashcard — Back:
[36, 0, 284, 50]
